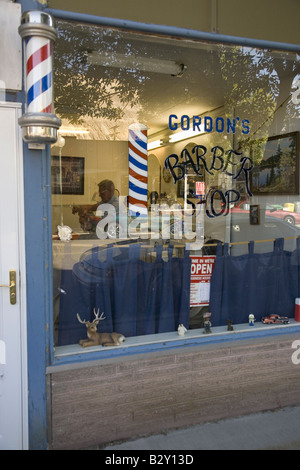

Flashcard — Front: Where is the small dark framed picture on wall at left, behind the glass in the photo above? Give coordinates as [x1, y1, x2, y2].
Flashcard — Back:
[51, 155, 84, 195]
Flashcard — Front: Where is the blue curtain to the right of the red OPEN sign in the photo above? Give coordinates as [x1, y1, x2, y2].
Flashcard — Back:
[210, 238, 300, 326]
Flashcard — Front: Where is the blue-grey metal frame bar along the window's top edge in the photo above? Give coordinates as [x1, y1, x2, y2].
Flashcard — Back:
[44, 8, 300, 52]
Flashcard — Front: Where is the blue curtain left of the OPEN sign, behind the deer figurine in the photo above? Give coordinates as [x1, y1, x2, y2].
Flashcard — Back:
[58, 244, 190, 345]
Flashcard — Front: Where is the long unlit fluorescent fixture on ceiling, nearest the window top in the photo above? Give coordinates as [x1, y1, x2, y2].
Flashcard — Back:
[86, 51, 186, 77]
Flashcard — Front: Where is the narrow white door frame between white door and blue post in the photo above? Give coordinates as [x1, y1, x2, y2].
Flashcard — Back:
[0, 101, 29, 450]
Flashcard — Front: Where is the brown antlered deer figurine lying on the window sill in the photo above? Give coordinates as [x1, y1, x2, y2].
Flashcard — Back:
[77, 309, 125, 348]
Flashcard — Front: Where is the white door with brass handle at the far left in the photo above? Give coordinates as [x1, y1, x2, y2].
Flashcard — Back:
[0, 103, 28, 450]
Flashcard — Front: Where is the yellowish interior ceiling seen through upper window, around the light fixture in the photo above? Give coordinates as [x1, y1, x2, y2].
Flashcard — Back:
[54, 22, 298, 140]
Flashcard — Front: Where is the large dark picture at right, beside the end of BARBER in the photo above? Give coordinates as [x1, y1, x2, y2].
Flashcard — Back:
[251, 132, 299, 195]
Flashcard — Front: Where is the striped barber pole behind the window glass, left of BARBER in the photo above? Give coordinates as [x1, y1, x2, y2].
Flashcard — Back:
[128, 123, 148, 216]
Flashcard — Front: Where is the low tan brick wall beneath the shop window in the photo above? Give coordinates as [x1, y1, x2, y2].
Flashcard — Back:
[49, 335, 300, 449]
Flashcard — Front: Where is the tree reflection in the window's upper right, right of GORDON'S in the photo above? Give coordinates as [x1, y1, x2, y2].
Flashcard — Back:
[220, 47, 300, 163]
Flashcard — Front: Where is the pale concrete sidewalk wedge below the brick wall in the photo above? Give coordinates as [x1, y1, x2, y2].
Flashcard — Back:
[103, 406, 300, 451]
